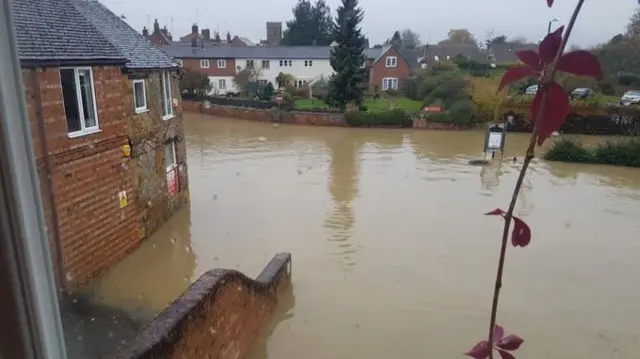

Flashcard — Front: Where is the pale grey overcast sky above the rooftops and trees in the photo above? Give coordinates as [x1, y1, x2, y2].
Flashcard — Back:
[100, 0, 638, 46]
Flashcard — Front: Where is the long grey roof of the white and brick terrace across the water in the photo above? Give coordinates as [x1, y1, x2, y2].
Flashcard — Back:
[162, 43, 382, 60]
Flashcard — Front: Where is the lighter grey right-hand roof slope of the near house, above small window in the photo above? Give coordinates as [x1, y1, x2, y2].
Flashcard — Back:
[71, 0, 177, 69]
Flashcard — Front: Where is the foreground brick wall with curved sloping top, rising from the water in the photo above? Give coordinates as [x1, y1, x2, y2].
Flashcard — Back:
[108, 253, 291, 359]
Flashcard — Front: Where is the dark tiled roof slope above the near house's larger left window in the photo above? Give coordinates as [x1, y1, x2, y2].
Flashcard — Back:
[10, 0, 125, 63]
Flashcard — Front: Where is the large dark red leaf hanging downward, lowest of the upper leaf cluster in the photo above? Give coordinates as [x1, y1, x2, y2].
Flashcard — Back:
[531, 82, 569, 145]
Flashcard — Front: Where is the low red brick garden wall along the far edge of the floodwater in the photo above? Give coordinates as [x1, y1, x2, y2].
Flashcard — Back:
[183, 101, 346, 126]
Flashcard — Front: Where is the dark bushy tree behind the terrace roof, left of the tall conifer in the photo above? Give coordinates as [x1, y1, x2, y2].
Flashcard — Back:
[281, 0, 333, 46]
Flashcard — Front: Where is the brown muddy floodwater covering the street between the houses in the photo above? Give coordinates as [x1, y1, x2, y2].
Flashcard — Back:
[80, 115, 640, 359]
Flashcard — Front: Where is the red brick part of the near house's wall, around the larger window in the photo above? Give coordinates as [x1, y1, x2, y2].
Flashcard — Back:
[23, 66, 139, 287]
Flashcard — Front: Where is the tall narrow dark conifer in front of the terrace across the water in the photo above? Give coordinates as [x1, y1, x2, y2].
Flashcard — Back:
[327, 0, 365, 109]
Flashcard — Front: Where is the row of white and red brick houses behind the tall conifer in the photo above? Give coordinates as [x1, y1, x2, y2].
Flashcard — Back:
[162, 41, 418, 95]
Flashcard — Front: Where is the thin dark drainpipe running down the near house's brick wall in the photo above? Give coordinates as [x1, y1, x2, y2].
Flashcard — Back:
[31, 67, 65, 294]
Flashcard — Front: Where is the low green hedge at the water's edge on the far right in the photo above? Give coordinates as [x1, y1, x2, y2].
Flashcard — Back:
[544, 138, 640, 167]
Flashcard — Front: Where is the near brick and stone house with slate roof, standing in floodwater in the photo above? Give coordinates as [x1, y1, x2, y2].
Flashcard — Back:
[11, 0, 188, 288]
